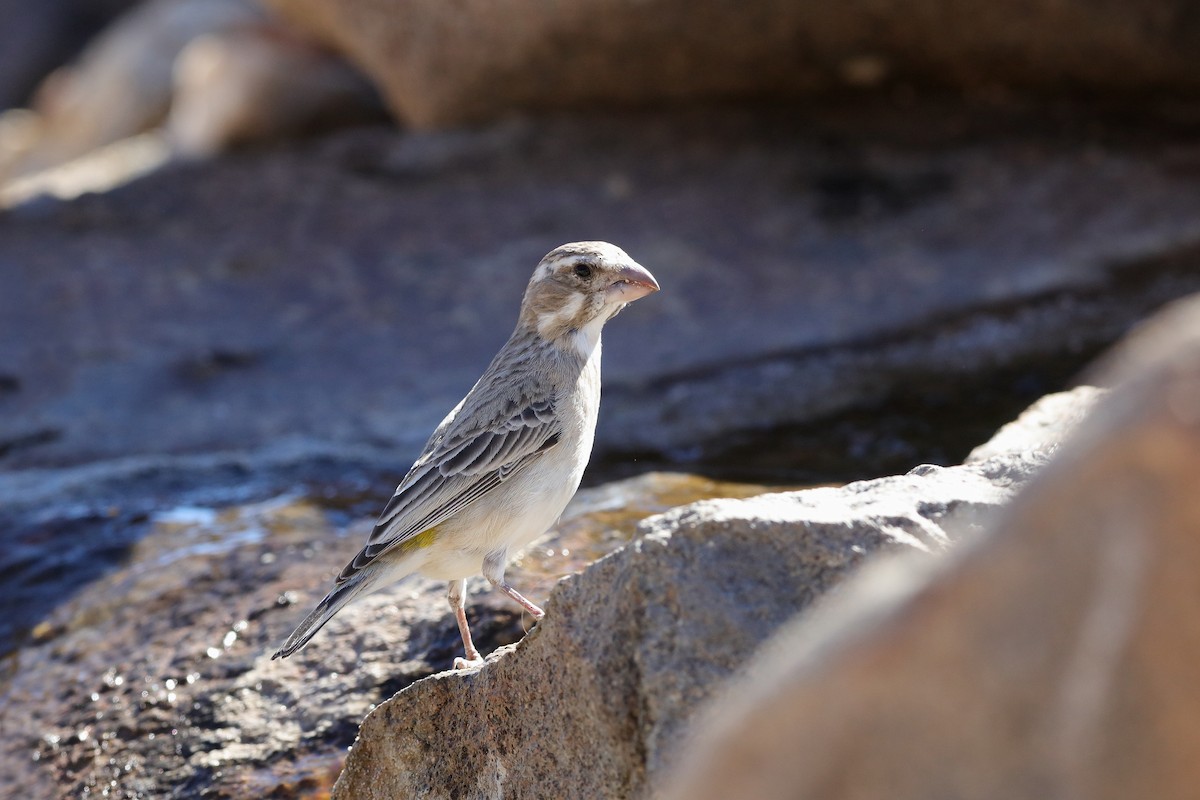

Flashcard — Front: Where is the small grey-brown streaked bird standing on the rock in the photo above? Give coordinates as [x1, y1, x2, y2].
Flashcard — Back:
[272, 241, 659, 668]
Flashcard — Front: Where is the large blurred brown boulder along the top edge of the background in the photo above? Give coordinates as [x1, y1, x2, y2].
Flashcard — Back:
[269, 0, 1200, 127]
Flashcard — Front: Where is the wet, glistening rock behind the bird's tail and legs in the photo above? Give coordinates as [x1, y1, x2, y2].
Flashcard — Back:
[0, 465, 763, 798]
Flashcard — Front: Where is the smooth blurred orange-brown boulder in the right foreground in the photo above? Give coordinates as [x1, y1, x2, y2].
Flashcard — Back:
[665, 289, 1200, 800]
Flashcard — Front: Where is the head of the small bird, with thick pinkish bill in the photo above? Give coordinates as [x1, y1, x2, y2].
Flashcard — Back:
[521, 241, 659, 350]
